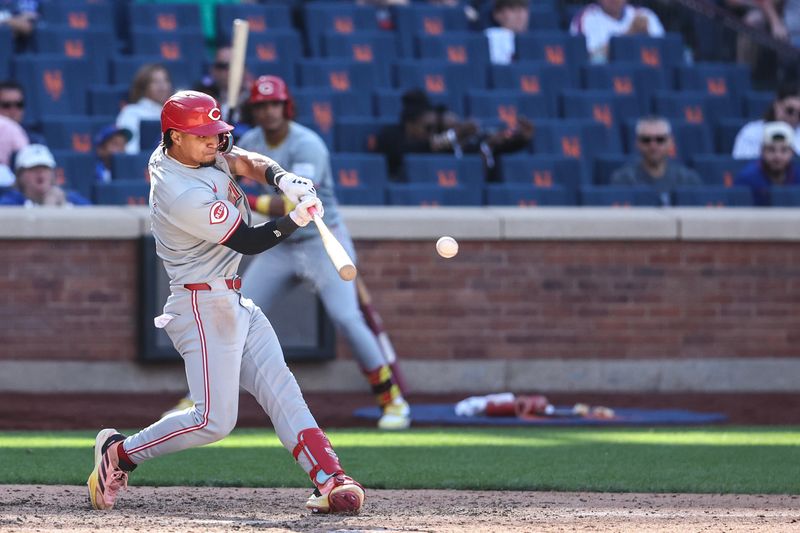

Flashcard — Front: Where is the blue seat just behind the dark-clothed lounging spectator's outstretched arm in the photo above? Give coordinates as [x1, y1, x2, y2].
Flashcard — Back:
[467, 89, 555, 128]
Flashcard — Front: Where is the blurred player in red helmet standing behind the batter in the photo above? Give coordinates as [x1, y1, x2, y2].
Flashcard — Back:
[238, 76, 410, 429]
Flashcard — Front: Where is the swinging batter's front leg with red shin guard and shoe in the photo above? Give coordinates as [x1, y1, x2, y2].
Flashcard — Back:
[240, 299, 364, 513]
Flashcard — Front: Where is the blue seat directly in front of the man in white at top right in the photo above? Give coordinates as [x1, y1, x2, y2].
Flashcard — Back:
[608, 33, 685, 69]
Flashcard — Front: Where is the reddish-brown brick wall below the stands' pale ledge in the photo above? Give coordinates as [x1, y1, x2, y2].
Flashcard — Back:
[0, 240, 800, 360]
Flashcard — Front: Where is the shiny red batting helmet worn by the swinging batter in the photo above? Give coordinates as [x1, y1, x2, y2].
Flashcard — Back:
[161, 91, 233, 135]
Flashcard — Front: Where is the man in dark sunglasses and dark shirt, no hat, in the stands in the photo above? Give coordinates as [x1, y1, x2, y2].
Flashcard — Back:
[611, 116, 703, 206]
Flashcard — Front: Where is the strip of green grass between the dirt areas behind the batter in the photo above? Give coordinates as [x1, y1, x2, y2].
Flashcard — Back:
[0, 426, 800, 494]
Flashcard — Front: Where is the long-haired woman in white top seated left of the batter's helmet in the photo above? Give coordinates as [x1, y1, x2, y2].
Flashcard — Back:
[117, 63, 173, 154]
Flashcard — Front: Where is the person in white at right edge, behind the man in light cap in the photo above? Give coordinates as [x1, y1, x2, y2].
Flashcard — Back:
[733, 84, 800, 159]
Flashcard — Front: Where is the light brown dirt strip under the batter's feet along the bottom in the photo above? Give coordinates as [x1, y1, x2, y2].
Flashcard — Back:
[0, 485, 800, 533]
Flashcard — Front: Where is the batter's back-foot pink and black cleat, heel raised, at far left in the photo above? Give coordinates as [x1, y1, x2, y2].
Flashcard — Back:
[86, 429, 128, 511]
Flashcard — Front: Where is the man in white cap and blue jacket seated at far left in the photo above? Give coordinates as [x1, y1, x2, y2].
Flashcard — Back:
[0, 144, 90, 207]
